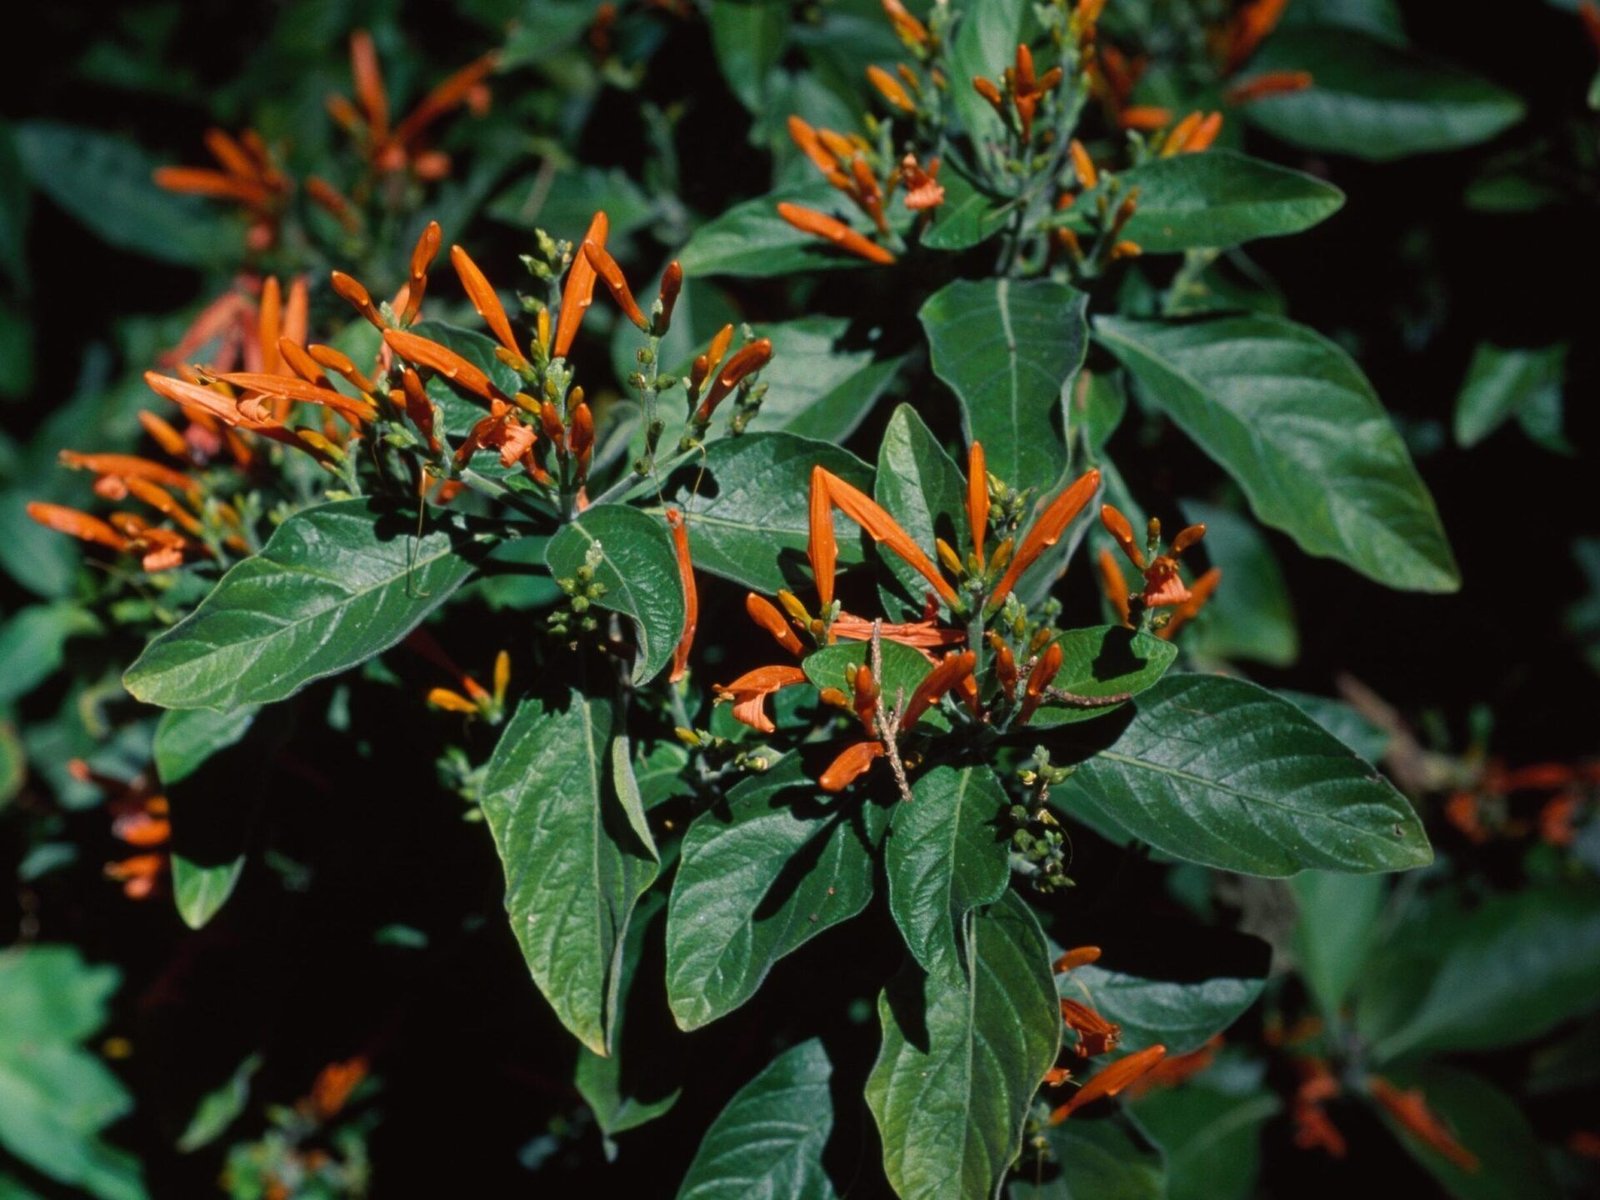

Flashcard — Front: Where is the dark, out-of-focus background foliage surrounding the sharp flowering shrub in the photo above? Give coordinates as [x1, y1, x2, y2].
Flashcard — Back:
[0, 0, 1600, 1198]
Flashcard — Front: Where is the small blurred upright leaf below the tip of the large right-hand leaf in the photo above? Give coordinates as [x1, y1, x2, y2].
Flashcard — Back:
[1290, 870, 1386, 1019]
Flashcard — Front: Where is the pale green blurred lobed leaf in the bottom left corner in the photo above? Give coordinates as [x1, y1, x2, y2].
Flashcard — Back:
[0, 946, 147, 1200]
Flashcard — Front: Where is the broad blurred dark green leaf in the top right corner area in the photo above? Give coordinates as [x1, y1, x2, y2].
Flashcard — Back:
[1240, 29, 1523, 162]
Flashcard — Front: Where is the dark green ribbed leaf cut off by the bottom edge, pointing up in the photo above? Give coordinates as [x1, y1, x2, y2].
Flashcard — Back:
[678, 1038, 838, 1200]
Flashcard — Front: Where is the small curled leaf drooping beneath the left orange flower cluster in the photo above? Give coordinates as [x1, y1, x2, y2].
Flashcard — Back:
[544, 504, 686, 683]
